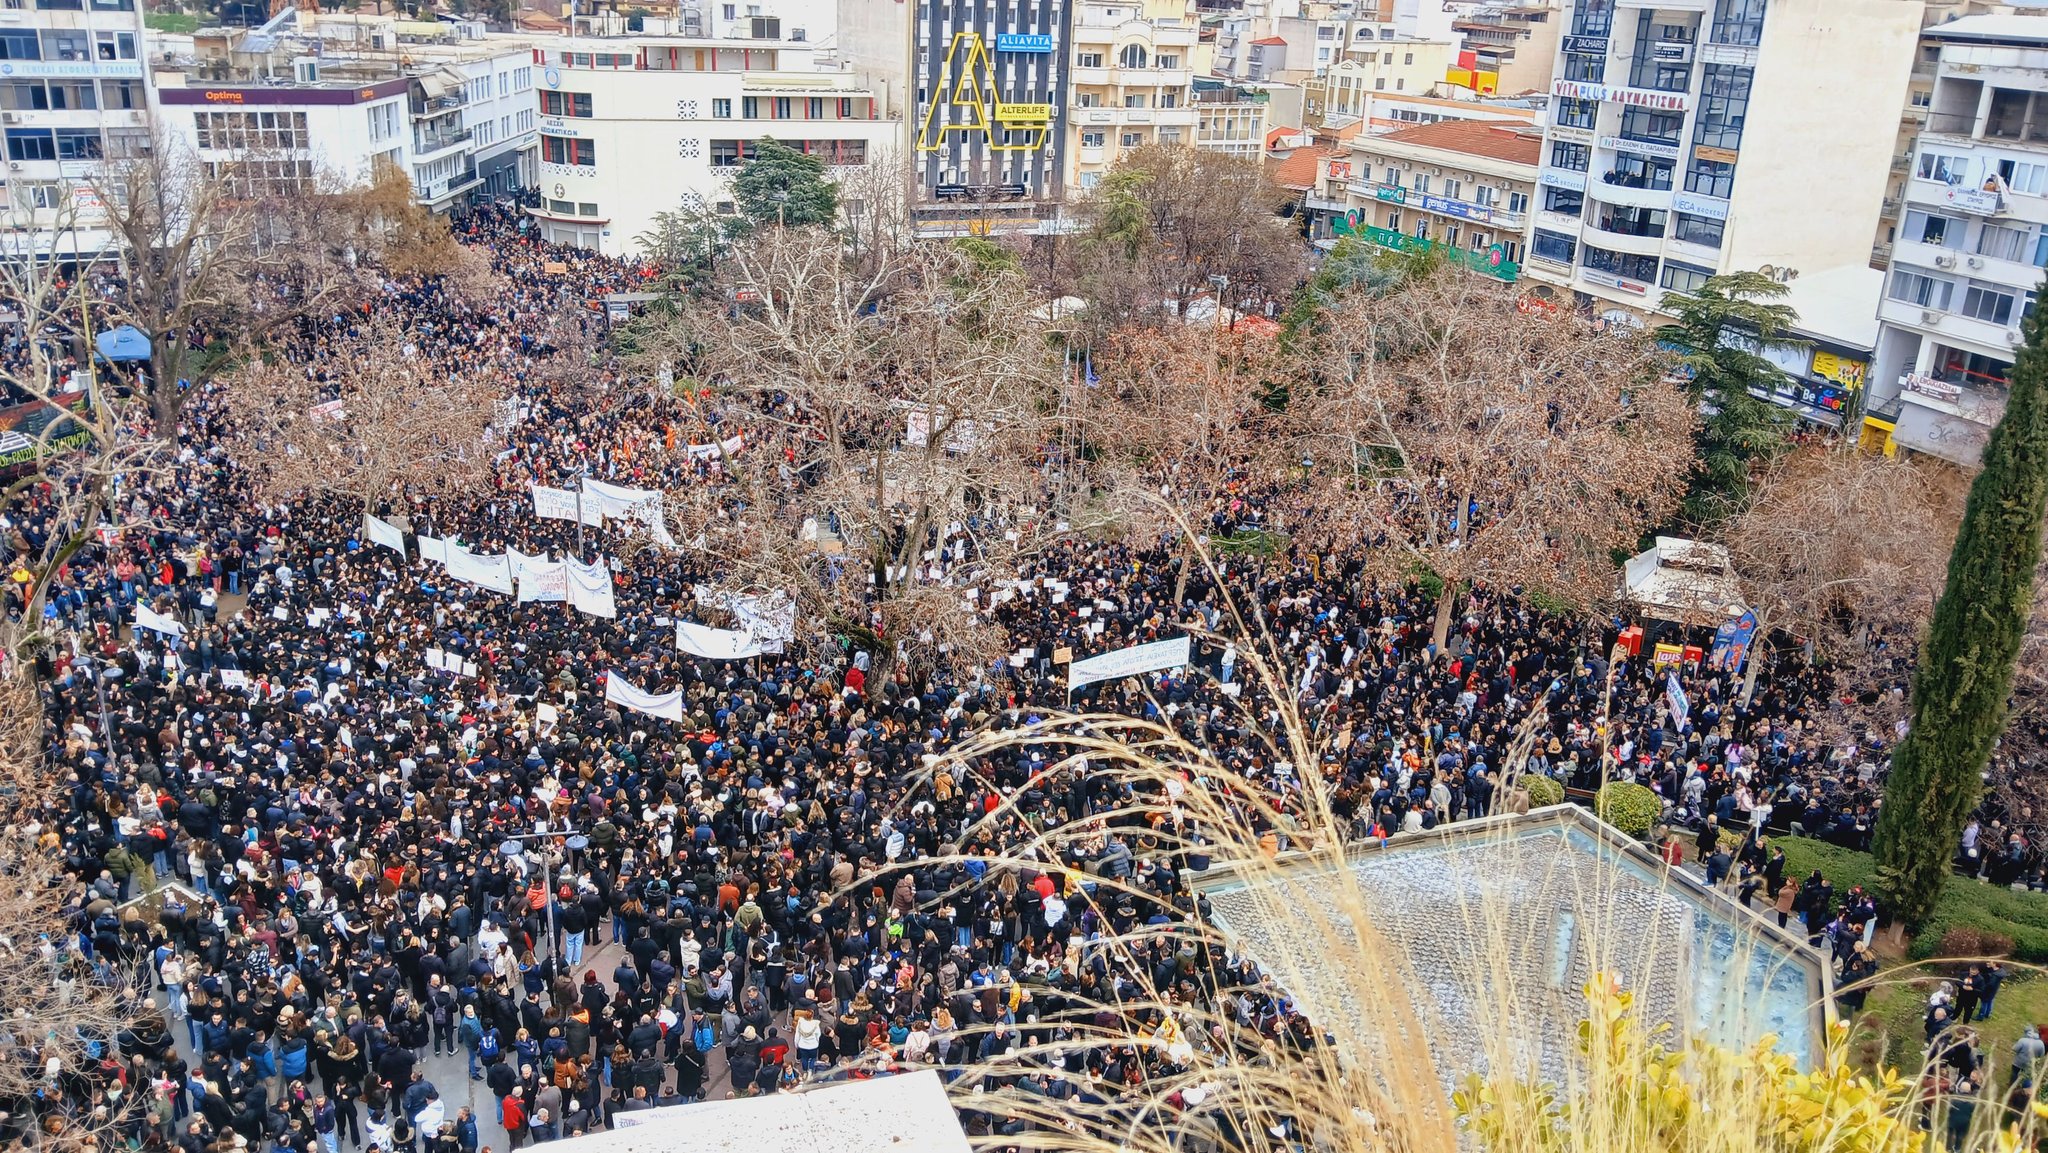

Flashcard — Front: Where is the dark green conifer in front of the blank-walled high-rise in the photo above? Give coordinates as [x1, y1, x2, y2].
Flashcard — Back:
[1657, 272, 1800, 524]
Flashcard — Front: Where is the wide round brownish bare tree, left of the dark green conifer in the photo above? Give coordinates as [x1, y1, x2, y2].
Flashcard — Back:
[1270, 268, 1694, 643]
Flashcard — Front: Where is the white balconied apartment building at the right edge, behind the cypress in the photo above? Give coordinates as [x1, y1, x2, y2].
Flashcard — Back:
[1868, 16, 2048, 465]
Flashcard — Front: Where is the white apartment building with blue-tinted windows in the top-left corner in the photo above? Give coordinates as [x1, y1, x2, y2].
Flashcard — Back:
[0, 0, 152, 254]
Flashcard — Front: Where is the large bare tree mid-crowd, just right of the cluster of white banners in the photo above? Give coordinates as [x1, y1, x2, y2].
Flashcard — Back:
[647, 229, 1059, 680]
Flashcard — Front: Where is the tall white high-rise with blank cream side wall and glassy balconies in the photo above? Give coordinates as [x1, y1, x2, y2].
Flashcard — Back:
[1524, 0, 1919, 317]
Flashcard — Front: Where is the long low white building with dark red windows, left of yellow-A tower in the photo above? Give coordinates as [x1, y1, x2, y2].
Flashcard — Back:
[528, 37, 899, 256]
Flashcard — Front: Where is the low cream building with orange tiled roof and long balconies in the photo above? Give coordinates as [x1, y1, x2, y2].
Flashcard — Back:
[1307, 121, 1542, 281]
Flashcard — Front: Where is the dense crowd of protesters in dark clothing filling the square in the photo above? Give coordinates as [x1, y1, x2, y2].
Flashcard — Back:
[0, 207, 2007, 1153]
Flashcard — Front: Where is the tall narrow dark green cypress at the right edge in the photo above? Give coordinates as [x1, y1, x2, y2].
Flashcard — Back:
[1874, 301, 2048, 926]
